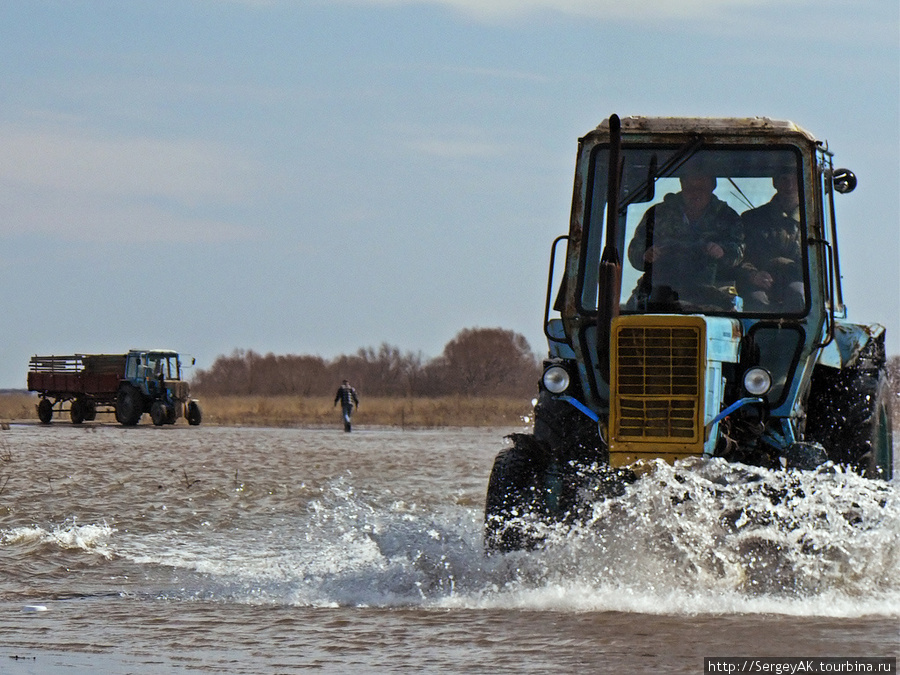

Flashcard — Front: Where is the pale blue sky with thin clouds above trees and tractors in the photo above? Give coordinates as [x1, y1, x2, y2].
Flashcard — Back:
[0, 0, 900, 388]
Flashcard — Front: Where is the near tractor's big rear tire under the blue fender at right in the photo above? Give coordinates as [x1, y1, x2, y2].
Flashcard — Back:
[806, 337, 894, 480]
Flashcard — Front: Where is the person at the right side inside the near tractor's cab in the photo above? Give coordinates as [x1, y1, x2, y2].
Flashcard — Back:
[738, 173, 806, 311]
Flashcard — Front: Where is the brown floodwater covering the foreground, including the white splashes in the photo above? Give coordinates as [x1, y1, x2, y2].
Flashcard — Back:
[0, 420, 900, 675]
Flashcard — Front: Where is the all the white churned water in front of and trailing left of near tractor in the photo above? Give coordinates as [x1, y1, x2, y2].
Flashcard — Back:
[110, 460, 900, 616]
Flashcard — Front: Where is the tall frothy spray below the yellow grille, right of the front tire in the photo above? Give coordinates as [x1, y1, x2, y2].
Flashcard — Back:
[486, 460, 900, 616]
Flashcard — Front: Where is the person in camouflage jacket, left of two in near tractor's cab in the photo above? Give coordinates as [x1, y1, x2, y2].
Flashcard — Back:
[626, 169, 743, 311]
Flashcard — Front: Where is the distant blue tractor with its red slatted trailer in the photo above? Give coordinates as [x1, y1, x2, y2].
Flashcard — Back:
[28, 349, 202, 426]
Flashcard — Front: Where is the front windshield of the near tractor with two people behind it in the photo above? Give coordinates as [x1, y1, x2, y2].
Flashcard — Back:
[581, 141, 808, 316]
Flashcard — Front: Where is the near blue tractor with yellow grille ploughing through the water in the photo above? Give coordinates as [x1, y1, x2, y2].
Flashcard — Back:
[485, 115, 893, 551]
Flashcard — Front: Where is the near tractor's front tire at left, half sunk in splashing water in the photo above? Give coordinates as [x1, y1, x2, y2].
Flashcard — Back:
[484, 434, 549, 553]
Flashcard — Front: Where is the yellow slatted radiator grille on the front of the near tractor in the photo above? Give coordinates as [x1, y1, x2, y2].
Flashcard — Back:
[612, 322, 703, 442]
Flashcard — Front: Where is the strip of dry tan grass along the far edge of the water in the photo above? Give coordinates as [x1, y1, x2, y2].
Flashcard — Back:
[0, 394, 532, 428]
